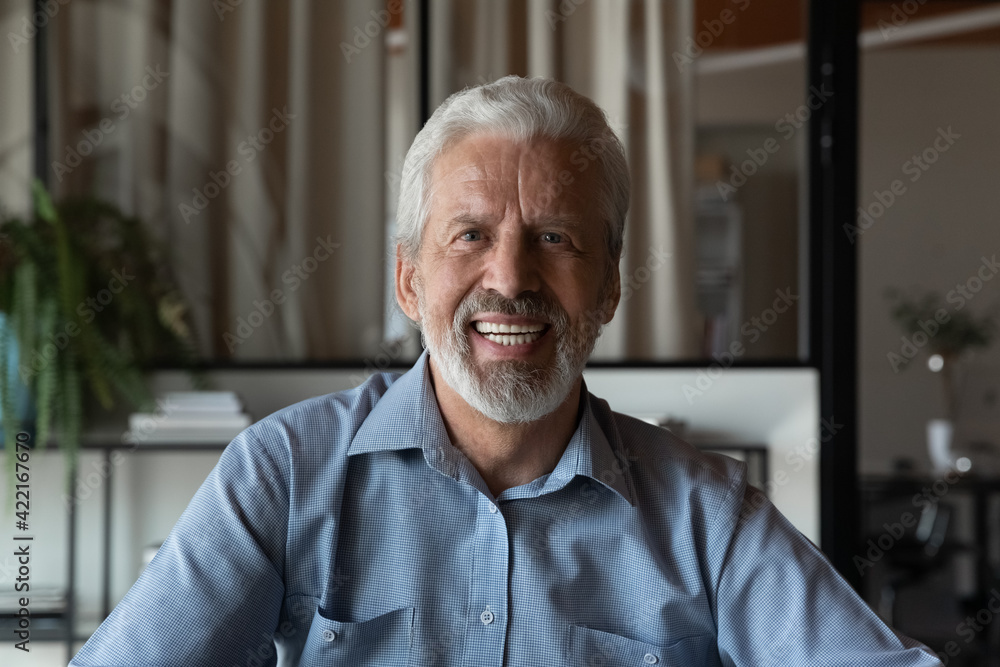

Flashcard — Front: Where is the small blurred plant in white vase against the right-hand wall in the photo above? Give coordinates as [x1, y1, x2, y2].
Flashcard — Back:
[886, 288, 997, 472]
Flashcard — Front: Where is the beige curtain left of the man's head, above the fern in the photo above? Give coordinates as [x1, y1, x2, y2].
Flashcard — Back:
[48, 0, 387, 360]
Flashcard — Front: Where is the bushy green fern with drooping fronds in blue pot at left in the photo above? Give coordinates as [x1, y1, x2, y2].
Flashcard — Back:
[0, 182, 201, 498]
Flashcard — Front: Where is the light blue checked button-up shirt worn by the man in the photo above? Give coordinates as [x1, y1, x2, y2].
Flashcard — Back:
[71, 353, 941, 667]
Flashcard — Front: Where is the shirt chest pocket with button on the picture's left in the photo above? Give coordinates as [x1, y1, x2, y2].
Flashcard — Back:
[299, 607, 415, 667]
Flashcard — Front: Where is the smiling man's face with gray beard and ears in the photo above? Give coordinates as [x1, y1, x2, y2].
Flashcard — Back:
[397, 134, 620, 422]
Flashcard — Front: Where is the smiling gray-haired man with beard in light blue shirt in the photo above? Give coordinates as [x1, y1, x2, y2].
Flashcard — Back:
[73, 77, 940, 667]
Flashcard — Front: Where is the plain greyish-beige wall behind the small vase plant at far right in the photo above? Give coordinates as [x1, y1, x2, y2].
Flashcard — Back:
[859, 46, 1000, 472]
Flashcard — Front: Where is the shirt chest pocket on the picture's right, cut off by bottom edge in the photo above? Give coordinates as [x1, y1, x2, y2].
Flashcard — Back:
[566, 625, 722, 667]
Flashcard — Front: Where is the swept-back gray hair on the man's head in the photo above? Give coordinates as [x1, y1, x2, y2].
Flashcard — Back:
[395, 76, 630, 264]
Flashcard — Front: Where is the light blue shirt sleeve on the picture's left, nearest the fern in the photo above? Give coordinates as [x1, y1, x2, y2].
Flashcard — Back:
[70, 425, 289, 667]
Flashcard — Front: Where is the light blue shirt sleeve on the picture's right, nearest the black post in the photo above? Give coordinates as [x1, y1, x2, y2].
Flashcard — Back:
[716, 486, 942, 667]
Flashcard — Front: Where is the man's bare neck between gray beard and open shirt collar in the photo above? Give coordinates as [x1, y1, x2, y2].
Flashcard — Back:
[429, 357, 580, 497]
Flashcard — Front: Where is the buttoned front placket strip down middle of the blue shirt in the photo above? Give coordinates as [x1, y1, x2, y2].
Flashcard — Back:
[463, 493, 510, 667]
